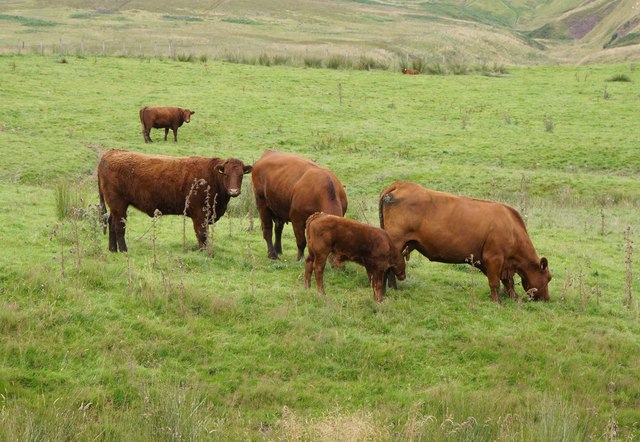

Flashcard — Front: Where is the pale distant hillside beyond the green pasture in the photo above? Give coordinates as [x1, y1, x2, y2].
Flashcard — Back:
[0, 0, 640, 65]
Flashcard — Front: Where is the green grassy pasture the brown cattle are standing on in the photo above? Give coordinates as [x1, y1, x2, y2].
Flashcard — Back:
[0, 55, 640, 440]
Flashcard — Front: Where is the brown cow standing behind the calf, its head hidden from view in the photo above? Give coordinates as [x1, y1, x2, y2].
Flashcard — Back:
[251, 150, 347, 260]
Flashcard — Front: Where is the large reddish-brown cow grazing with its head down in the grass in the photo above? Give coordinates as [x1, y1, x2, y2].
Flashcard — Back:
[379, 181, 551, 302]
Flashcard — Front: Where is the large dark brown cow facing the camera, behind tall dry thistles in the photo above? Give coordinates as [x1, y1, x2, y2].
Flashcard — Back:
[97, 150, 251, 252]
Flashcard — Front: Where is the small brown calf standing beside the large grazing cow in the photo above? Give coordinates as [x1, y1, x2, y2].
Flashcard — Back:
[304, 212, 405, 302]
